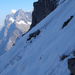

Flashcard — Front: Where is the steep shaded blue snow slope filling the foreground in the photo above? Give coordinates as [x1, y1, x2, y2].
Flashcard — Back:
[0, 0, 75, 75]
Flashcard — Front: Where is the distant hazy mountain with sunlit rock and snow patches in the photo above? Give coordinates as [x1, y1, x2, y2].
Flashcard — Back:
[0, 9, 32, 55]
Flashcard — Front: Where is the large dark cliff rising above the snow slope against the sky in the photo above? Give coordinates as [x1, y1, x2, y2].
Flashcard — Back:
[30, 0, 59, 29]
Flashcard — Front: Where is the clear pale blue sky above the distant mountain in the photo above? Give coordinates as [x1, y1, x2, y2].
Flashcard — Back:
[0, 0, 38, 29]
